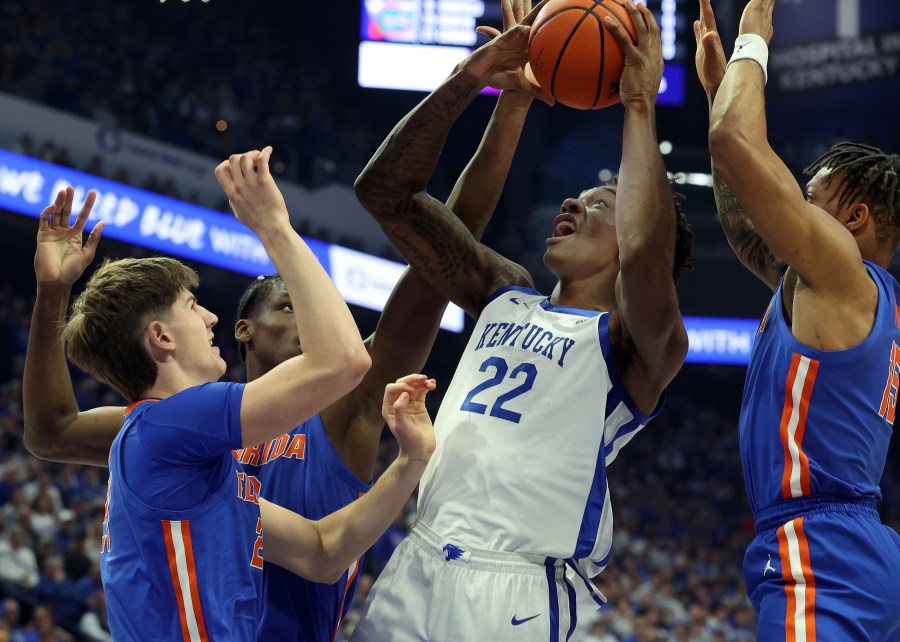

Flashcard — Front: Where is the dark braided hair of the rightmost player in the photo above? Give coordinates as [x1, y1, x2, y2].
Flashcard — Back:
[804, 143, 900, 246]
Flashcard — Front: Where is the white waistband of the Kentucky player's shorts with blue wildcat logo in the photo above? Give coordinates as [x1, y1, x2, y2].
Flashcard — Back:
[409, 522, 565, 577]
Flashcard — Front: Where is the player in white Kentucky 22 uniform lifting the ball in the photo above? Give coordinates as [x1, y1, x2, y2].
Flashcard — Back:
[354, 3, 690, 641]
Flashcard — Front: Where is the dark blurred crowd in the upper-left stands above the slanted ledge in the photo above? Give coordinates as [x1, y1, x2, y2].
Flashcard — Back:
[0, 0, 376, 190]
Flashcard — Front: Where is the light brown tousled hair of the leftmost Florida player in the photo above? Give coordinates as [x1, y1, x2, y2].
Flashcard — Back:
[60, 257, 200, 402]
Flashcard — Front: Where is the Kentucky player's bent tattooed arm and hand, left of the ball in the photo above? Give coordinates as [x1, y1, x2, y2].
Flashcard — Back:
[355, 7, 538, 316]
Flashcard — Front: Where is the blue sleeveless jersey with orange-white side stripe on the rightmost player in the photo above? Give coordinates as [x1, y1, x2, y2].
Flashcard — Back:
[740, 262, 900, 513]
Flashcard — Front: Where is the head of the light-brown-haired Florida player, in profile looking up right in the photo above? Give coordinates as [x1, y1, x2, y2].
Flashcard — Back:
[61, 257, 225, 402]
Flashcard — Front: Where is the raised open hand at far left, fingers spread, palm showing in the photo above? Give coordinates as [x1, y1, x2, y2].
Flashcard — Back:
[34, 187, 103, 286]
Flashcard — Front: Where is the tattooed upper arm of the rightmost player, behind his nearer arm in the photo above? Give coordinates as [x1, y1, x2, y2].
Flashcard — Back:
[712, 162, 787, 291]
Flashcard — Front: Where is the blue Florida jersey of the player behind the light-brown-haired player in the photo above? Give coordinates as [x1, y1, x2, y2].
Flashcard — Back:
[234, 415, 370, 642]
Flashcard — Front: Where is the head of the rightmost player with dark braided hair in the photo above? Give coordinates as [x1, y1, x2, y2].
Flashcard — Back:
[805, 143, 900, 250]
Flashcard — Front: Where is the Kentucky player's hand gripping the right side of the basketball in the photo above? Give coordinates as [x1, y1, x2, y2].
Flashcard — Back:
[604, 0, 663, 107]
